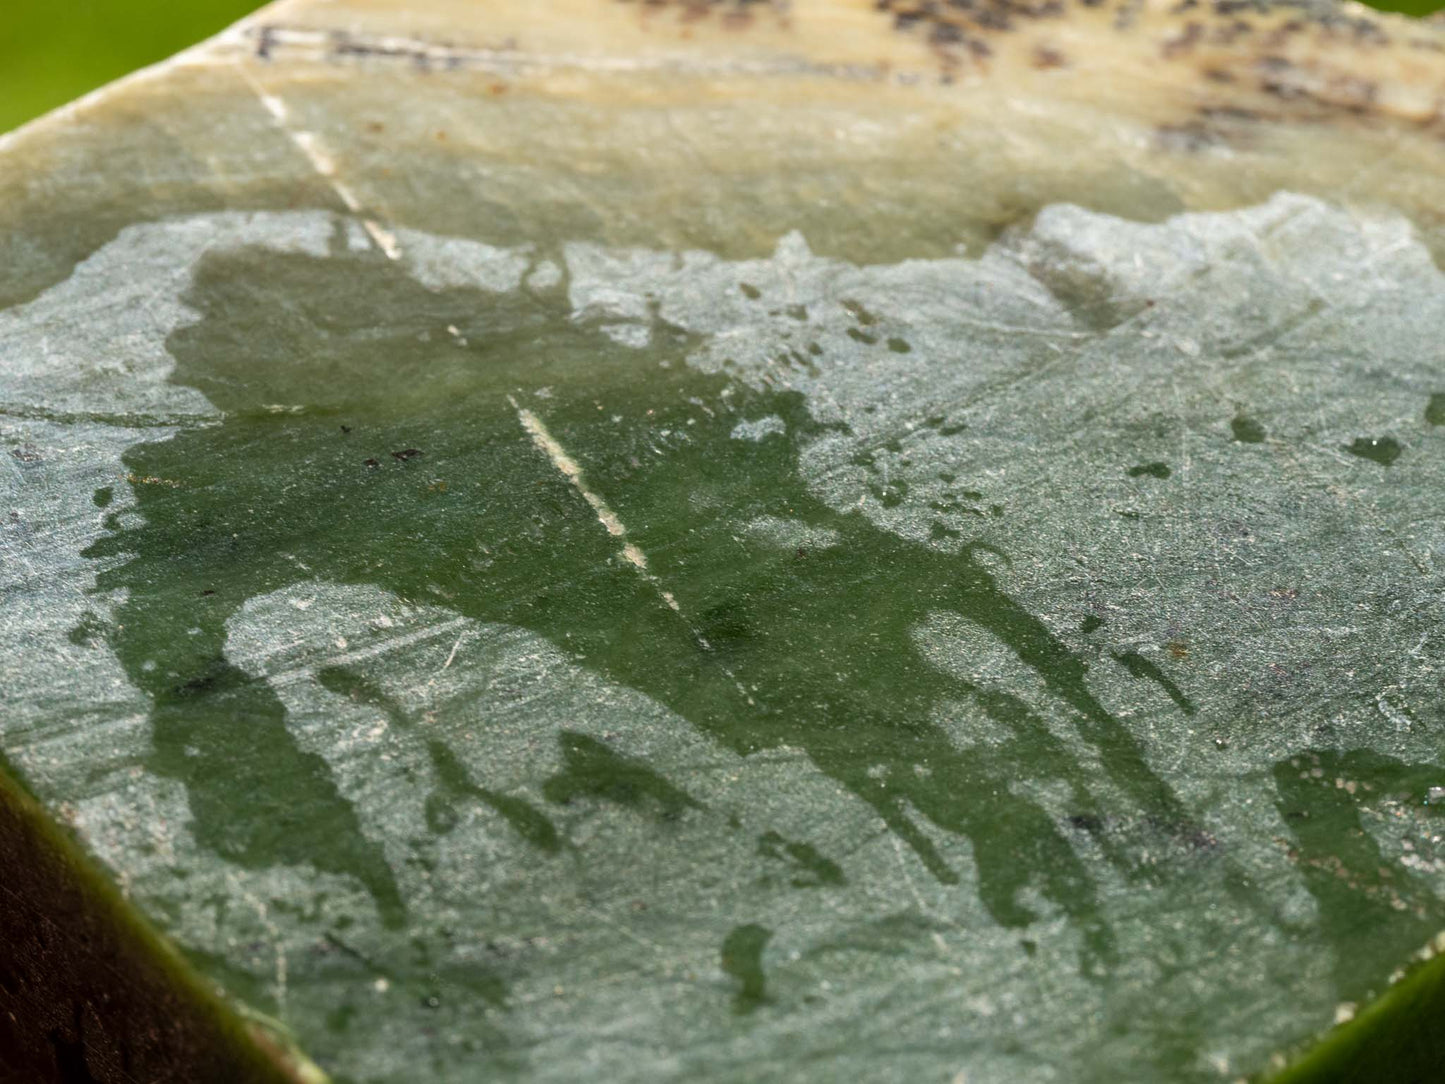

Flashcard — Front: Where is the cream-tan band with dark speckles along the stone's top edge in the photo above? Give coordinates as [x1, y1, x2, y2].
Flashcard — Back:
[8, 0, 1445, 313]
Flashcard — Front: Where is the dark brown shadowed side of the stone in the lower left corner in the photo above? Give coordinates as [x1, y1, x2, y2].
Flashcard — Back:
[0, 769, 303, 1084]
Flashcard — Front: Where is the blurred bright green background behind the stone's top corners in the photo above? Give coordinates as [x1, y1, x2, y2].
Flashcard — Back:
[0, 0, 1445, 132]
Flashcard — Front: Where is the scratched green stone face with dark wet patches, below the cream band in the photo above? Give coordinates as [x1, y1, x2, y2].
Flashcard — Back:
[8, 197, 1445, 1081]
